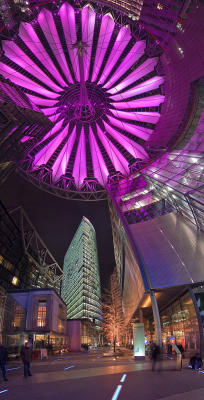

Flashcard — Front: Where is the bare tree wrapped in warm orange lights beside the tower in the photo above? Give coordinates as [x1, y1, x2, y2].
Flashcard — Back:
[102, 269, 124, 353]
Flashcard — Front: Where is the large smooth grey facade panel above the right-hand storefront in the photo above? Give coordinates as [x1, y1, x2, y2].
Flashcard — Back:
[129, 212, 204, 289]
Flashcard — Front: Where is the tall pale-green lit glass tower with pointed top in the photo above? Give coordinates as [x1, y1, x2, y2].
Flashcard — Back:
[61, 217, 101, 328]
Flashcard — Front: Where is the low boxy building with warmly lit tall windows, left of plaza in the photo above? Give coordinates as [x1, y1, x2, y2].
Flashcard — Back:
[1, 289, 68, 355]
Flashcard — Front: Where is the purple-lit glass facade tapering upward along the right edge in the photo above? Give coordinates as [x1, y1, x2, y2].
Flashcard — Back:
[142, 92, 204, 231]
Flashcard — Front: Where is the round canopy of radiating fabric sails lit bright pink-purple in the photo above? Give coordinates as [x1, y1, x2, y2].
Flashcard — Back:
[0, 2, 165, 191]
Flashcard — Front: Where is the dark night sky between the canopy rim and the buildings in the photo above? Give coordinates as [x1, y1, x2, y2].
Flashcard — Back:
[0, 174, 115, 289]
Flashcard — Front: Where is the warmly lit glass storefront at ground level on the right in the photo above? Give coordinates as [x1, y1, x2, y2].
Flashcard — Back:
[143, 287, 204, 355]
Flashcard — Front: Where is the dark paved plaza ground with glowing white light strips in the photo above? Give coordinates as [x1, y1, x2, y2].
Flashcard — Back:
[0, 353, 204, 400]
